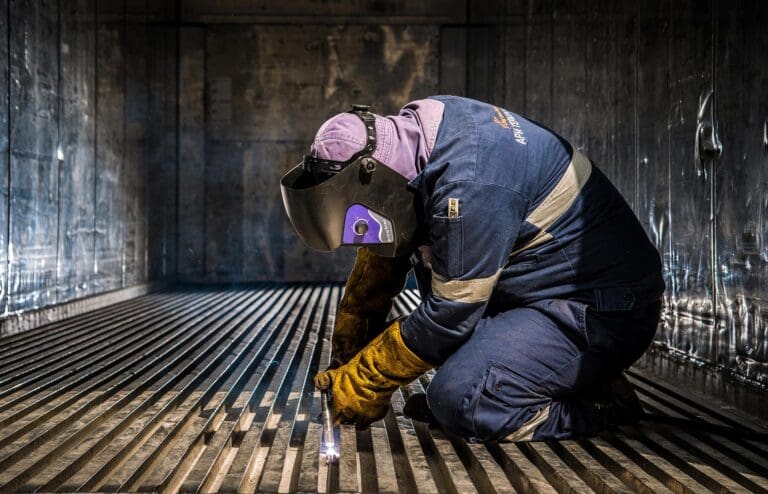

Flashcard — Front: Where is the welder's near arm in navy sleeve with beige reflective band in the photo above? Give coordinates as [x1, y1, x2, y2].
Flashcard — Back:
[402, 181, 528, 365]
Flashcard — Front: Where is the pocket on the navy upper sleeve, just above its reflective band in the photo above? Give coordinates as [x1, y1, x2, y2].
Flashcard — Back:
[430, 215, 464, 278]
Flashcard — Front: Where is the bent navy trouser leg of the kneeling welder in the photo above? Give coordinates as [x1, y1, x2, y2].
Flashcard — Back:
[427, 302, 660, 441]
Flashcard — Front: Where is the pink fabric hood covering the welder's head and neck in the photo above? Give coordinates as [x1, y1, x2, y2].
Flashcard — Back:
[311, 99, 445, 180]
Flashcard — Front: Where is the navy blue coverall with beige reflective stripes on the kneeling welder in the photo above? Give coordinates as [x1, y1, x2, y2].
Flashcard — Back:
[401, 96, 664, 441]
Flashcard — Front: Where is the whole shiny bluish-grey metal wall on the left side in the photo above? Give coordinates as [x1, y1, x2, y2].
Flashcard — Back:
[0, 0, 177, 315]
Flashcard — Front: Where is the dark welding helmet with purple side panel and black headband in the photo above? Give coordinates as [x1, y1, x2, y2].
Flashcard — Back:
[280, 105, 418, 257]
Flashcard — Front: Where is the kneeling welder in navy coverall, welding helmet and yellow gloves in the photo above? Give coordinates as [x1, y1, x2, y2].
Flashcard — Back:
[281, 96, 664, 442]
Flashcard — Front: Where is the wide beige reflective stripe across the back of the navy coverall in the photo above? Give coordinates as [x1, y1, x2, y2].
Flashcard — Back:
[510, 149, 592, 256]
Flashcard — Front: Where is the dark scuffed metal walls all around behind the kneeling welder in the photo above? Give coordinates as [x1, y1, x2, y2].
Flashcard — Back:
[0, 0, 768, 408]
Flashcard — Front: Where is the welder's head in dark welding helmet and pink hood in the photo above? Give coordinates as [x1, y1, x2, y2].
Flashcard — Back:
[280, 99, 444, 257]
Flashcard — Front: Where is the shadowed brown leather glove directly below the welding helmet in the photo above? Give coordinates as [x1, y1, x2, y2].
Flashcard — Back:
[330, 247, 411, 368]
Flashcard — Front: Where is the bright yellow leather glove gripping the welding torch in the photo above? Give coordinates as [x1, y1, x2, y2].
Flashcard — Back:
[315, 321, 433, 429]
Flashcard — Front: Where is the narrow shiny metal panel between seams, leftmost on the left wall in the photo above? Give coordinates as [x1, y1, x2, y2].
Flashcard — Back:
[7, 0, 59, 312]
